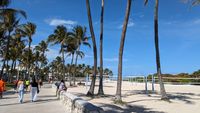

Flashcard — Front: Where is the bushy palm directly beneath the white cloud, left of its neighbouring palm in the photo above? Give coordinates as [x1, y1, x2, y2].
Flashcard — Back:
[47, 26, 70, 77]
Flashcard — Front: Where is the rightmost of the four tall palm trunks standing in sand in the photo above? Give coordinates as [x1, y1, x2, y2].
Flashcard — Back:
[154, 0, 168, 100]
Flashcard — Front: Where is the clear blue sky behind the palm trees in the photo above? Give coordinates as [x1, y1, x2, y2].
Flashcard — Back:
[11, 0, 200, 75]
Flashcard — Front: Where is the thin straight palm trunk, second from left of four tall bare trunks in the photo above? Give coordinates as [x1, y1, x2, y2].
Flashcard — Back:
[98, 0, 104, 95]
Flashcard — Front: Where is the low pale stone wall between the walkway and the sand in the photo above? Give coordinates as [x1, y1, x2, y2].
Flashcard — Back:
[52, 84, 104, 113]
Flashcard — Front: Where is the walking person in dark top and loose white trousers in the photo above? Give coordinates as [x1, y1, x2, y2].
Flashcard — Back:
[30, 78, 39, 102]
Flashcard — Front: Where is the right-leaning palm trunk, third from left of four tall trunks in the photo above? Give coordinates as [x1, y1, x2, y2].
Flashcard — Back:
[115, 0, 132, 102]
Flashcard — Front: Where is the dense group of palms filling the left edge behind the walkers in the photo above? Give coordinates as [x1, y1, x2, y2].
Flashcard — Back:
[0, 0, 47, 81]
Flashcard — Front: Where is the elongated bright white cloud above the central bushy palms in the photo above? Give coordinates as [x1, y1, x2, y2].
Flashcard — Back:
[45, 18, 78, 29]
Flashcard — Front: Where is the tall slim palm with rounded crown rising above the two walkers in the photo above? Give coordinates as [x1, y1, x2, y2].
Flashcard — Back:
[21, 22, 36, 78]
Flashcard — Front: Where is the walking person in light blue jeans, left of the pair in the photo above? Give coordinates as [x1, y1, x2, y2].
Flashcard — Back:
[17, 79, 25, 103]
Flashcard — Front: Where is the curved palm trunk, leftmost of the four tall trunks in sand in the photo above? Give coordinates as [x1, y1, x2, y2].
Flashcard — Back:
[86, 0, 97, 96]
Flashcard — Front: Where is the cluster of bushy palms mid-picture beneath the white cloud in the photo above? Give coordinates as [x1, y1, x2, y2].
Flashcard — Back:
[47, 25, 90, 85]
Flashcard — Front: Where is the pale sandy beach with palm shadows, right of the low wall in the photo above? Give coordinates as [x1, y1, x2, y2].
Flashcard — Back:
[68, 81, 200, 113]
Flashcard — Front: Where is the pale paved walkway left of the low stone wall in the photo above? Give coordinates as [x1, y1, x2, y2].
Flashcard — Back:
[0, 84, 66, 113]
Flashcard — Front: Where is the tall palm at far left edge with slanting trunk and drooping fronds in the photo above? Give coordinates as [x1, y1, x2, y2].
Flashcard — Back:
[0, 5, 26, 75]
